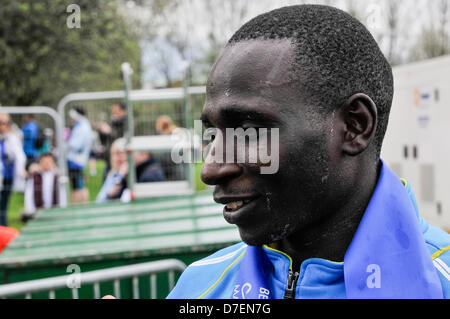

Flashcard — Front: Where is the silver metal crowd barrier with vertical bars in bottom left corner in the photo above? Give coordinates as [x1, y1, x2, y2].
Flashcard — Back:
[0, 259, 186, 299]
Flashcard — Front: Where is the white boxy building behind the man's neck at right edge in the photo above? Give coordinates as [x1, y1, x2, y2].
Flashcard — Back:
[381, 56, 450, 230]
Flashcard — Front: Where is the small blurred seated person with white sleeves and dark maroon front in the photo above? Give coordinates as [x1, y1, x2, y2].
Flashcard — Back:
[22, 153, 66, 222]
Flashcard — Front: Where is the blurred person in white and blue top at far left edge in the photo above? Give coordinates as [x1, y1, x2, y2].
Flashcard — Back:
[0, 114, 26, 226]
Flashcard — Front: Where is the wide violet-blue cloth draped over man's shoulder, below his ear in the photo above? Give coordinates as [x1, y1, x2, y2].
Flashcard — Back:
[344, 161, 443, 299]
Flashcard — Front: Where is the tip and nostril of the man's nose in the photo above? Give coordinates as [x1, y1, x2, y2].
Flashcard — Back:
[201, 162, 242, 185]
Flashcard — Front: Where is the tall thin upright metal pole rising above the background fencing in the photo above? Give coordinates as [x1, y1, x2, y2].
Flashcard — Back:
[122, 62, 136, 200]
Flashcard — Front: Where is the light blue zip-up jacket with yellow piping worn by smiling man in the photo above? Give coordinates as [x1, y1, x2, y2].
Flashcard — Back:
[167, 165, 450, 299]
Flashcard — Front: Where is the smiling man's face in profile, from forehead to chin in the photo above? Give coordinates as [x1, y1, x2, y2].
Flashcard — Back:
[202, 40, 342, 245]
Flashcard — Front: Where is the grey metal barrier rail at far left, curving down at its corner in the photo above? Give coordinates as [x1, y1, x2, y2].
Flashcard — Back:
[0, 106, 68, 207]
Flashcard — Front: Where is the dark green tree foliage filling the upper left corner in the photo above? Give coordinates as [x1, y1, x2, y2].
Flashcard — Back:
[0, 0, 141, 106]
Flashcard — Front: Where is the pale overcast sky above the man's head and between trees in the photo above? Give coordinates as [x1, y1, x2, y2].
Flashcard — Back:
[124, 0, 446, 87]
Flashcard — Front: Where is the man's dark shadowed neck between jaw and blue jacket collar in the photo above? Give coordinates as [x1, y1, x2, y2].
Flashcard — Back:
[279, 161, 379, 271]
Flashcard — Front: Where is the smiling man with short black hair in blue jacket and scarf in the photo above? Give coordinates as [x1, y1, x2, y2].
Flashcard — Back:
[169, 5, 450, 299]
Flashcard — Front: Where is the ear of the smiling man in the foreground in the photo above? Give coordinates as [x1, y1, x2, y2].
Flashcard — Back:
[341, 93, 378, 156]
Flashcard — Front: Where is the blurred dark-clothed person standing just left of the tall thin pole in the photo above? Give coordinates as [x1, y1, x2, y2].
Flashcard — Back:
[96, 102, 127, 180]
